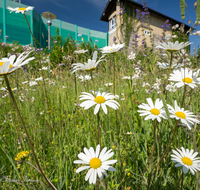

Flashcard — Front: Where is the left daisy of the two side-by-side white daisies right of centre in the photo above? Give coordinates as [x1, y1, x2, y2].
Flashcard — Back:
[138, 98, 167, 122]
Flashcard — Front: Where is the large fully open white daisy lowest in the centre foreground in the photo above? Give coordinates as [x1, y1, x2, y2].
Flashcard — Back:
[74, 145, 117, 184]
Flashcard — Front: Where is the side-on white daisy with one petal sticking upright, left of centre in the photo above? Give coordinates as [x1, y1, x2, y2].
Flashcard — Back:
[72, 51, 104, 73]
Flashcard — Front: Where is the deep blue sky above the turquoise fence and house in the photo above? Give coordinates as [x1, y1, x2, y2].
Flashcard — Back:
[21, 0, 199, 51]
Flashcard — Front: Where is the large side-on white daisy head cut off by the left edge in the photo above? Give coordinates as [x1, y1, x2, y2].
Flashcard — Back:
[0, 52, 35, 75]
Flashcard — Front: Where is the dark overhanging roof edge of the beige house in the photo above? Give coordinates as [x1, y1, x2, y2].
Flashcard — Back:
[100, 0, 192, 30]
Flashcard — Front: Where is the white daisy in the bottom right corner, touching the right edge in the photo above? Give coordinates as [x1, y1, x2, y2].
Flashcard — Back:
[171, 147, 200, 175]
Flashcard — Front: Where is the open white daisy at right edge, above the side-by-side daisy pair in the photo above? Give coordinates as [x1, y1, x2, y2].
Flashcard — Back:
[169, 68, 200, 88]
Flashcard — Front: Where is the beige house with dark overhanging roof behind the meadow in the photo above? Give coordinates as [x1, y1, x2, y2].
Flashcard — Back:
[100, 0, 190, 50]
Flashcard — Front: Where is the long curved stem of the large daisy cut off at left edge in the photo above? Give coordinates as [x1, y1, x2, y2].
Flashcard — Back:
[4, 75, 57, 190]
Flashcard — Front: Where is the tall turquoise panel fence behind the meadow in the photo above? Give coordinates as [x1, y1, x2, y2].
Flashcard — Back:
[0, 0, 108, 47]
